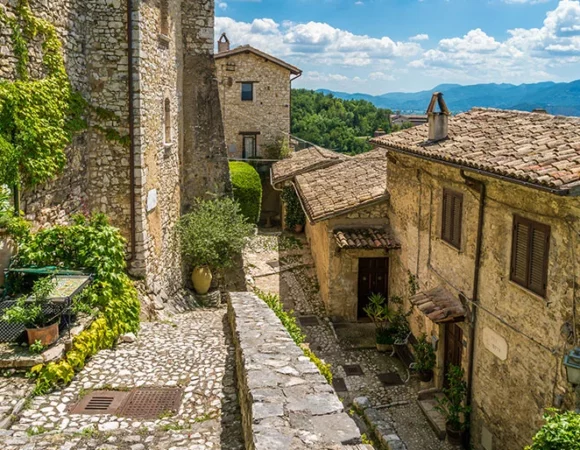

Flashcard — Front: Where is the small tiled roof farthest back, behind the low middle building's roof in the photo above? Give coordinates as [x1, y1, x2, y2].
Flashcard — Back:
[272, 147, 350, 185]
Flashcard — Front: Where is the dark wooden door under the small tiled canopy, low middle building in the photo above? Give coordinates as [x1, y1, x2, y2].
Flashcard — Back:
[357, 258, 389, 319]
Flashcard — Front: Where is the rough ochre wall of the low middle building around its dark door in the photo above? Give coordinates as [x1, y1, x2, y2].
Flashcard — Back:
[306, 202, 397, 321]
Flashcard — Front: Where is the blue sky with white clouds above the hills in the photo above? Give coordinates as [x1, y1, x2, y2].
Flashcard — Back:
[215, 0, 580, 95]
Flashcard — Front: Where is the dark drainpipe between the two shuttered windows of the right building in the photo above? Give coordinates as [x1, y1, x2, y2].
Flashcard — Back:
[460, 170, 486, 442]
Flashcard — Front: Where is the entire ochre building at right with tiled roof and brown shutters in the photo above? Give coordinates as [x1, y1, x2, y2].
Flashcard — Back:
[373, 99, 580, 450]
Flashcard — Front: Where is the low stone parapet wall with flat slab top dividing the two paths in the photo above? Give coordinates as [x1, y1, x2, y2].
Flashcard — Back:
[228, 292, 361, 450]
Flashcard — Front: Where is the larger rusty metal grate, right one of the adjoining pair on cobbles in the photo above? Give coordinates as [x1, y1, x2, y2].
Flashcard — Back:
[118, 388, 183, 419]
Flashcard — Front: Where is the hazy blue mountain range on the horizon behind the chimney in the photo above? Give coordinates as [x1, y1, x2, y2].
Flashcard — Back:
[317, 80, 580, 116]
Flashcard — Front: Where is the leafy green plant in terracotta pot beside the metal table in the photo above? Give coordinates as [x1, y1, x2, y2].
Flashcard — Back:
[2, 277, 59, 347]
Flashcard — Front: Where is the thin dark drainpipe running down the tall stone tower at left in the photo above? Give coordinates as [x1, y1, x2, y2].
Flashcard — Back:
[127, 0, 137, 262]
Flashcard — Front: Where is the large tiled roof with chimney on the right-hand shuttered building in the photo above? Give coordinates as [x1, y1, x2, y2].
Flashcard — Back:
[371, 108, 580, 191]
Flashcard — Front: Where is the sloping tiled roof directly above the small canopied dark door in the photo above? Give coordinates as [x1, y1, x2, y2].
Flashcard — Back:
[295, 149, 388, 223]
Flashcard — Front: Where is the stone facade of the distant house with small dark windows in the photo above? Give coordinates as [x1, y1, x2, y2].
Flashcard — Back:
[216, 53, 290, 158]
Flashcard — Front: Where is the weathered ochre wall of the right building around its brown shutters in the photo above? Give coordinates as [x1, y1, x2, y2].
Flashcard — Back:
[387, 154, 580, 450]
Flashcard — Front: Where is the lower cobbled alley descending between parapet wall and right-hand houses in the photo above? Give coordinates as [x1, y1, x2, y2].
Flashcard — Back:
[244, 233, 457, 450]
